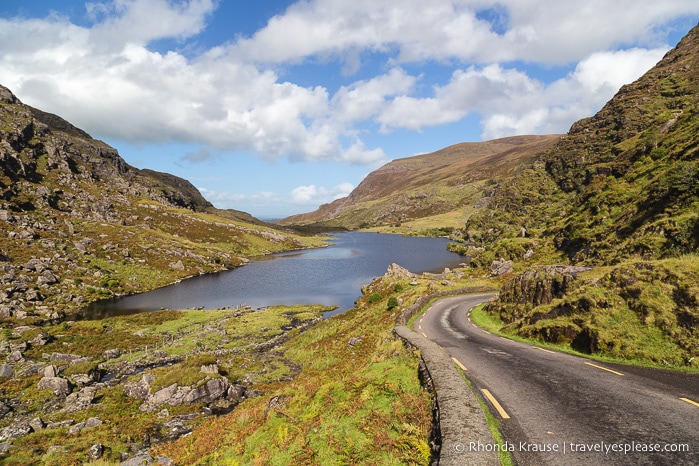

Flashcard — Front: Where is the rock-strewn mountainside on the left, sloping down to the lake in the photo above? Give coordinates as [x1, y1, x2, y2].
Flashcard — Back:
[0, 86, 322, 322]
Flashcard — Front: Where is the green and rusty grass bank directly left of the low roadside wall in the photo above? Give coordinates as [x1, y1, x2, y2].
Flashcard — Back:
[150, 274, 432, 465]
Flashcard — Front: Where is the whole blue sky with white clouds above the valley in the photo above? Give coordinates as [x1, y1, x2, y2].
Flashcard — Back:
[0, 0, 699, 219]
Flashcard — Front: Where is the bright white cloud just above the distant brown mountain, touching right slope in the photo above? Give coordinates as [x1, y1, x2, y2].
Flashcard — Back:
[377, 48, 665, 139]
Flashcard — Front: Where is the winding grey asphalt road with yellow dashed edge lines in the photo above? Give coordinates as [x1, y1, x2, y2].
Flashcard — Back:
[413, 295, 699, 466]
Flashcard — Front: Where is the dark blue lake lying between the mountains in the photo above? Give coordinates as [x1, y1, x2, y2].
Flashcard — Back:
[85, 232, 463, 319]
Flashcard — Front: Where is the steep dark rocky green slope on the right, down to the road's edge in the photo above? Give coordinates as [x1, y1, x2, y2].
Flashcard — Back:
[476, 22, 699, 367]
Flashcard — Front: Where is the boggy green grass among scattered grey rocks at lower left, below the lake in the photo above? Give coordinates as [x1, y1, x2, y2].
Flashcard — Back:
[0, 306, 328, 465]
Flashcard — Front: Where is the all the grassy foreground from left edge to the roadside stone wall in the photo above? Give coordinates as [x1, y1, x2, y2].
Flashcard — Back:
[0, 270, 456, 465]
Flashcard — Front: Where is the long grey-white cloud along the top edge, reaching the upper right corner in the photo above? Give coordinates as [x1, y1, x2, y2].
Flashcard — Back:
[232, 0, 699, 64]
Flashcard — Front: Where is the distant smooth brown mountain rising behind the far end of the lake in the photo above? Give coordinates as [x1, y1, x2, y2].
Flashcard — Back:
[278, 135, 560, 228]
